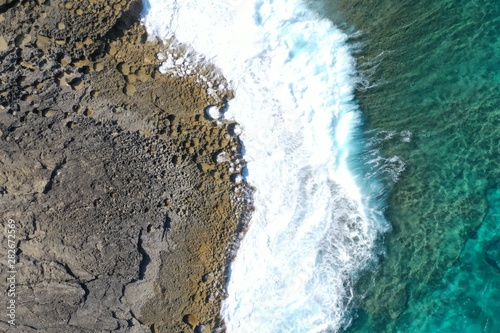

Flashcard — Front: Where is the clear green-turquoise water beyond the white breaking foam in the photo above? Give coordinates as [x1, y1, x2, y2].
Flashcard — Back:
[312, 0, 500, 332]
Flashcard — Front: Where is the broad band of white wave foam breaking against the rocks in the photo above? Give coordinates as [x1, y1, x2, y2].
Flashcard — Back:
[143, 0, 386, 333]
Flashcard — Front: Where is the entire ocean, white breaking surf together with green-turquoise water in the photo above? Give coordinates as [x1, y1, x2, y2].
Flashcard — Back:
[142, 0, 500, 333]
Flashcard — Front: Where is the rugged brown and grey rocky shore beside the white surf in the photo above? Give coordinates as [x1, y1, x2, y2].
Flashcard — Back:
[0, 0, 250, 333]
